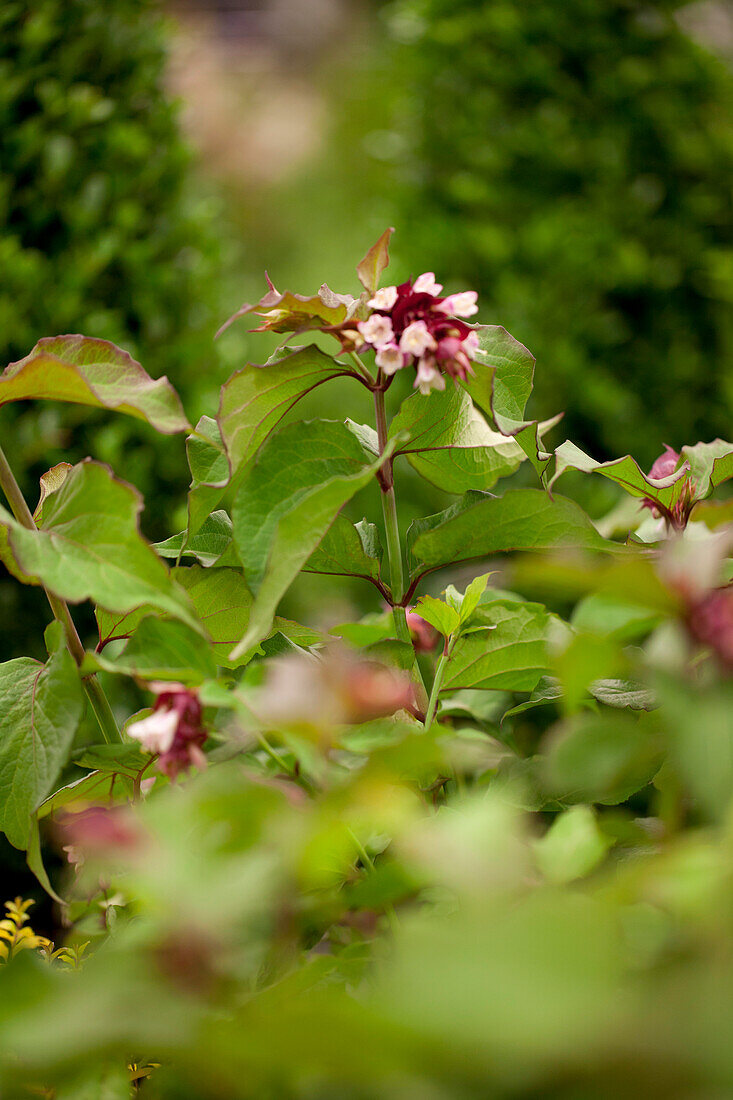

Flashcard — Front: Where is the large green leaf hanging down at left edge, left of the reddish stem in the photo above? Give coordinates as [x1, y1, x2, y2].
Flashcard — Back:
[0, 647, 84, 849]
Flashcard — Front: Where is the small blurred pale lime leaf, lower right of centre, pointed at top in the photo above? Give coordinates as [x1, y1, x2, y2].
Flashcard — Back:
[533, 806, 613, 886]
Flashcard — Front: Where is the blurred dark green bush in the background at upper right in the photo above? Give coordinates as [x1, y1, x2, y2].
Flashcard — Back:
[383, 0, 733, 463]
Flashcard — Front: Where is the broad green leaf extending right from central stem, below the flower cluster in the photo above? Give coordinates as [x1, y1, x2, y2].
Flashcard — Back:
[407, 488, 620, 579]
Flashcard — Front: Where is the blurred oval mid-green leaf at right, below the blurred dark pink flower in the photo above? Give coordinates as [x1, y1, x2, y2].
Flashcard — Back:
[544, 711, 663, 805]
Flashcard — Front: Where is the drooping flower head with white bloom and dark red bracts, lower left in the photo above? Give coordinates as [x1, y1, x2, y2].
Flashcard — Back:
[128, 683, 207, 779]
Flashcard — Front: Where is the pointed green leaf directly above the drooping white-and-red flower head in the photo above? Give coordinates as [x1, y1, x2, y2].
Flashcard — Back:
[84, 615, 217, 683]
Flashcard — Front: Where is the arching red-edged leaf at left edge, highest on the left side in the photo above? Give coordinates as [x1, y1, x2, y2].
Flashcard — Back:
[0, 336, 189, 433]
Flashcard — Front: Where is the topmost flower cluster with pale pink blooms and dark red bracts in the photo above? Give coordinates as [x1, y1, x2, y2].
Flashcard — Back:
[357, 272, 479, 394]
